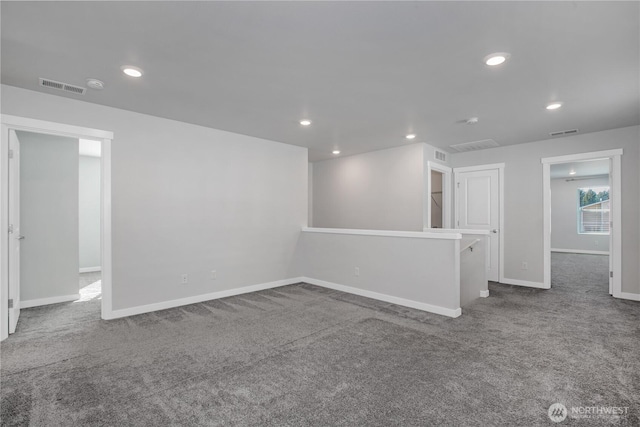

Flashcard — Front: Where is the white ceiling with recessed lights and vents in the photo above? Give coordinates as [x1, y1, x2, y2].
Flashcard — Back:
[1, 1, 640, 160]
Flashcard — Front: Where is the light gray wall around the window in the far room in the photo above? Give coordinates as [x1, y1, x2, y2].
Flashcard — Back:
[551, 176, 609, 252]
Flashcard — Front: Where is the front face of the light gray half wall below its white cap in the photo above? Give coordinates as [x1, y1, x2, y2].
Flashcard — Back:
[299, 232, 460, 310]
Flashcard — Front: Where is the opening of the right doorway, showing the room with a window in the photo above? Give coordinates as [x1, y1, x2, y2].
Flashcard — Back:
[550, 159, 612, 294]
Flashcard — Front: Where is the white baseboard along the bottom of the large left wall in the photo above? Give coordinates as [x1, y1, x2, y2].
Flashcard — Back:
[103, 277, 305, 320]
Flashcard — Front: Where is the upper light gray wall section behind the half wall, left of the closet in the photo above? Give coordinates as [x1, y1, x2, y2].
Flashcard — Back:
[313, 144, 424, 231]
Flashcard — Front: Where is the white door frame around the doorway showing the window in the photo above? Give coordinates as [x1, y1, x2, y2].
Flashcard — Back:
[540, 148, 623, 298]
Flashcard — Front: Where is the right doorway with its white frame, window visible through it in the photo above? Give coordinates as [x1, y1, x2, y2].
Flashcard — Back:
[542, 150, 622, 297]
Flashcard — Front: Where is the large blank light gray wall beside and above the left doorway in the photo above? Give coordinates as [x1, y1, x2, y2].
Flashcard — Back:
[1, 85, 307, 309]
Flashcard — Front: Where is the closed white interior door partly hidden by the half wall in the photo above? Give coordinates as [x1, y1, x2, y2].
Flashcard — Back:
[455, 169, 501, 282]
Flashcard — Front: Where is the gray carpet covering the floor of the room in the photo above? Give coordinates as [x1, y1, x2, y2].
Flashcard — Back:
[1, 260, 640, 426]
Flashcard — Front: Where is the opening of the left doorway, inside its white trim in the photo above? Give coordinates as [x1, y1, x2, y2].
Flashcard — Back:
[14, 130, 102, 316]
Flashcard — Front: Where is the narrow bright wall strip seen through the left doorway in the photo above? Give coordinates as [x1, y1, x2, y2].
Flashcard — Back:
[78, 156, 101, 269]
